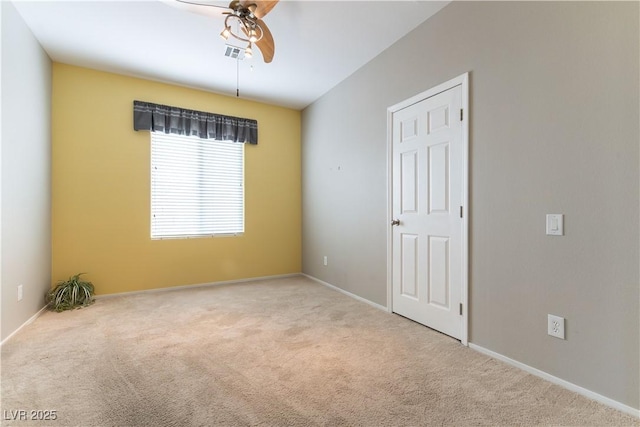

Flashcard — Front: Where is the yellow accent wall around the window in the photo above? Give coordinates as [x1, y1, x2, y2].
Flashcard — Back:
[52, 63, 301, 294]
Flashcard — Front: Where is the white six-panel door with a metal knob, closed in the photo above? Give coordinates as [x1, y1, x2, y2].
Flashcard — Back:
[391, 84, 467, 344]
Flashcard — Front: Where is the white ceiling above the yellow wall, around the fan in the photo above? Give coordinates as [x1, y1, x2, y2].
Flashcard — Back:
[14, 0, 449, 109]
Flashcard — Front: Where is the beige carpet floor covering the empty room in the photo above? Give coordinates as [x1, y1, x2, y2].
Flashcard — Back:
[1, 277, 640, 427]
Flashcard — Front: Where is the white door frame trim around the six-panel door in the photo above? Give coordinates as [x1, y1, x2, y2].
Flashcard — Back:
[387, 72, 470, 346]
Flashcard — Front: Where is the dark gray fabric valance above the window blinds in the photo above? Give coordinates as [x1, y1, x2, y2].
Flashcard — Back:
[133, 101, 258, 144]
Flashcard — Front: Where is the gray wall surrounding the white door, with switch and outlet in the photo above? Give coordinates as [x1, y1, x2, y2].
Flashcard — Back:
[303, 2, 640, 408]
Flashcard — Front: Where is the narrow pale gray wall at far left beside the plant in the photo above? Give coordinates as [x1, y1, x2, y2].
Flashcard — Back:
[0, 1, 51, 340]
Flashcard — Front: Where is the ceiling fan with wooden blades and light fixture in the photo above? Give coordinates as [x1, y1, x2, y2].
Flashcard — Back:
[171, 0, 279, 63]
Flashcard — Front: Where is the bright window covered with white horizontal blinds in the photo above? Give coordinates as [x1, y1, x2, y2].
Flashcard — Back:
[151, 132, 244, 239]
